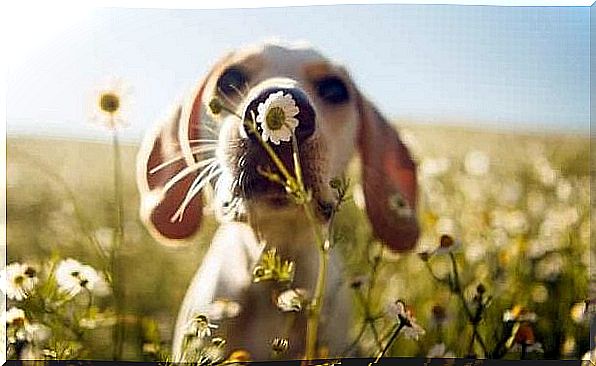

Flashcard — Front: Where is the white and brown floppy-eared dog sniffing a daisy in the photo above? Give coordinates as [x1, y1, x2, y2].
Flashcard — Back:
[137, 43, 419, 361]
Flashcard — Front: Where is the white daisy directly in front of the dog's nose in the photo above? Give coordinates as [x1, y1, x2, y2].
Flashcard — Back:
[257, 91, 300, 145]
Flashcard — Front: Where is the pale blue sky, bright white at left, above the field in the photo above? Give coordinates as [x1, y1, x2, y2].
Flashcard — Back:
[6, 5, 590, 142]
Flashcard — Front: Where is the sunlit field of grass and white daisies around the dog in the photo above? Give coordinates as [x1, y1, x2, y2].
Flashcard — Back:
[3, 124, 593, 360]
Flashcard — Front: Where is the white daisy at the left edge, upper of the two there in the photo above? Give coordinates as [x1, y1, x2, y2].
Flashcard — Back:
[0, 263, 39, 301]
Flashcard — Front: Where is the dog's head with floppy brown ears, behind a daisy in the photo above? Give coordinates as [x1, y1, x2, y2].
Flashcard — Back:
[138, 40, 418, 251]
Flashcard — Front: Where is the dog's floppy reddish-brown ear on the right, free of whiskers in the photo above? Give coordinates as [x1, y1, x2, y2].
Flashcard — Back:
[357, 95, 419, 251]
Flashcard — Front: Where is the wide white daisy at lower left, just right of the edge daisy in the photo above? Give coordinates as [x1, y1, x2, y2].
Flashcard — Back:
[56, 258, 109, 296]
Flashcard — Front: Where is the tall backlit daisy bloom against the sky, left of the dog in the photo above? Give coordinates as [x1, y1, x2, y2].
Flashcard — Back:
[91, 79, 130, 130]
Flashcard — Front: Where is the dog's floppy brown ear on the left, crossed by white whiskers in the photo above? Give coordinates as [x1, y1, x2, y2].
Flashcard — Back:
[137, 81, 210, 244]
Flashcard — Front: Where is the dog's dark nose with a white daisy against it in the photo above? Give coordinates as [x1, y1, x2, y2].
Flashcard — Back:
[243, 87, 316, 142]
